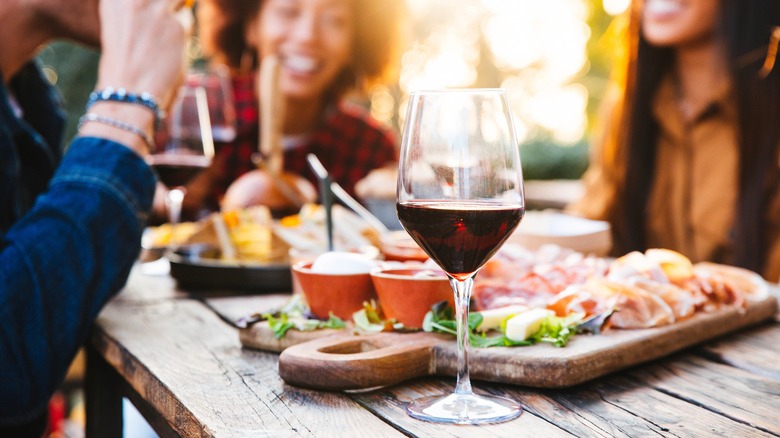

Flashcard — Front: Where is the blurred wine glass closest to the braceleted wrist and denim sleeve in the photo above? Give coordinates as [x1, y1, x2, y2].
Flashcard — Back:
[147, 81, 214, 250]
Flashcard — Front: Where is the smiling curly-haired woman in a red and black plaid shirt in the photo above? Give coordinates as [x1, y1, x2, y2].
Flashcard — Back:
[176, 0, 403, 217]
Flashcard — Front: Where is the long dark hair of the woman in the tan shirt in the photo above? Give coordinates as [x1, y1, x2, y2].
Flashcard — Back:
[610, 0, 780, 272]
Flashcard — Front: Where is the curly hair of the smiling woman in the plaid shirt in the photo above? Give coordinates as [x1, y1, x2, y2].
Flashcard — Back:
[200, 0, 405, 98]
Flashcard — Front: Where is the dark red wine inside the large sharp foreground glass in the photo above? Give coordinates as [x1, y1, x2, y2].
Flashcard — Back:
[397, 201, 524, 280]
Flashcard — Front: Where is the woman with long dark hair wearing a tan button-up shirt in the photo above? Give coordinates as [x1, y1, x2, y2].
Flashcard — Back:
[570, 0, 780, 281]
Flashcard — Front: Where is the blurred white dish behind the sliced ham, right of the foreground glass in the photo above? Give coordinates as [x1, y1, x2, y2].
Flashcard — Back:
[509, 210, 612, 256]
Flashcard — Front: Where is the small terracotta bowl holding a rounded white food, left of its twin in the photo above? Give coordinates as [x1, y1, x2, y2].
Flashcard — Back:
[292, 262, 376, 321]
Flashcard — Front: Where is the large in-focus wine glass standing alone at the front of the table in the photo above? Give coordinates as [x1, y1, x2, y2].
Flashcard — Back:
[396, 89, 525, 424]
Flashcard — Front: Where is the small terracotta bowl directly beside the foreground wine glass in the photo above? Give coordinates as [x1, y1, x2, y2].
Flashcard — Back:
[371, 268, 455, 328]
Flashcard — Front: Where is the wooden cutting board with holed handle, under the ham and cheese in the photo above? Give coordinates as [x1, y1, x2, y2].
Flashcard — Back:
[240, 295, 777, 390]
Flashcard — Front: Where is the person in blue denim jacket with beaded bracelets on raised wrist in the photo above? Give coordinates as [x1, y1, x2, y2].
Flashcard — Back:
[0, 0, 189, 437]
